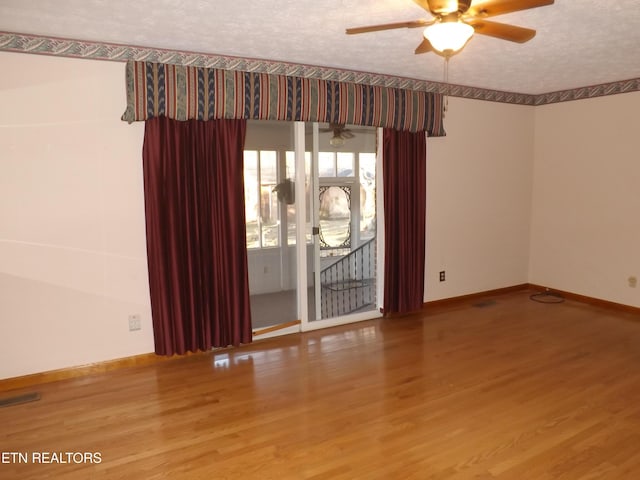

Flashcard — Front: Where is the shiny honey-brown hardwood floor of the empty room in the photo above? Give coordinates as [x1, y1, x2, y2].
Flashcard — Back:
[0, 292, 640, 480]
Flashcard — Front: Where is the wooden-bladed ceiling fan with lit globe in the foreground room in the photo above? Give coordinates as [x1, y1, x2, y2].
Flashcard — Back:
[346, 0, 554, 58]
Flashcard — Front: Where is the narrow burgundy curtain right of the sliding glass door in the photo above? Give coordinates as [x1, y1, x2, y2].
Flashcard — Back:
[382, 128, 427, 315]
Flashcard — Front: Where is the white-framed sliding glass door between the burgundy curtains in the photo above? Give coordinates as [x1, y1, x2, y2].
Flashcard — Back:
[244, 121, 382, 338]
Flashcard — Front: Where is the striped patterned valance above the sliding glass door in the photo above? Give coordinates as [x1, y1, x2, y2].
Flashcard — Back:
[122, 61, 444, 137]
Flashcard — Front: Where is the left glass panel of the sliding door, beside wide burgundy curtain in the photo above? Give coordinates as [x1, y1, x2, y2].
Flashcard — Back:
[244, 121, 300, 333]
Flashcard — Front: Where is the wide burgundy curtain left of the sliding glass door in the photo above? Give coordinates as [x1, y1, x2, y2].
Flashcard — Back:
[143, 117, 251, 355]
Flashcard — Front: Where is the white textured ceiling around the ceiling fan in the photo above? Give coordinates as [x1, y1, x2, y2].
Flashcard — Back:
[0, 0, 640, 95]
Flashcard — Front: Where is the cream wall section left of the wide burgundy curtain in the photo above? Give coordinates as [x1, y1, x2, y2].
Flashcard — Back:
[0, 53, 153, 378]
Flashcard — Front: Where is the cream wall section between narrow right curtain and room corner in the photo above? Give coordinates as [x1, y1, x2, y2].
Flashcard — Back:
[424, 98, 534, 301]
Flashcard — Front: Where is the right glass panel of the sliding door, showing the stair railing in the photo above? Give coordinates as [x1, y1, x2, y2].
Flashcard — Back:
[315, 125, 378, 321]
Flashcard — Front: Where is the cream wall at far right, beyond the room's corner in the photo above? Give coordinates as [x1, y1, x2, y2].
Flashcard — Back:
[529, 92, 640, 307]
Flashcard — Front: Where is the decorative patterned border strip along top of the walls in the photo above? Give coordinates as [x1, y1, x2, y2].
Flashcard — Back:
[0, 31, 640, 105]
